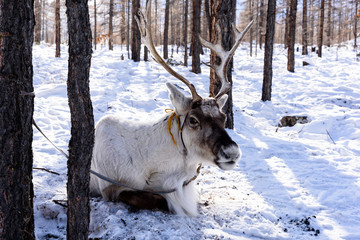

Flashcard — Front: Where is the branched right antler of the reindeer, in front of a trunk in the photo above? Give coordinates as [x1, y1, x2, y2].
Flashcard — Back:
[199, 21, 254, 99]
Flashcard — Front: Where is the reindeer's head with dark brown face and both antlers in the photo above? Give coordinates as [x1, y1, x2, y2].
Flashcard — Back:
[135, 0, 252, 170]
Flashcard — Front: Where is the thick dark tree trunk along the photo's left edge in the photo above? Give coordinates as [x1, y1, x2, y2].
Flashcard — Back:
[0, 0, 35, 239]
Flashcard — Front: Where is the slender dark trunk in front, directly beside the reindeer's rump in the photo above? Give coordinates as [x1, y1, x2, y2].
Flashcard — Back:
[66, 0, 94, 240]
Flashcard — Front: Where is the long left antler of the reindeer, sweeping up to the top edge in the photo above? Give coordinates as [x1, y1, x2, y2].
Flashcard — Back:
[135, 0, 202, 102]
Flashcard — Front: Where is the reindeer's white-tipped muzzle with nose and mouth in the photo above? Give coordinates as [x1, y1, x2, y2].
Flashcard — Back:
[216, 142, 241, 170]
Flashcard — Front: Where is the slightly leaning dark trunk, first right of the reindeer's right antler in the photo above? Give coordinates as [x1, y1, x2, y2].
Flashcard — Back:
[261, 0, 276, 101]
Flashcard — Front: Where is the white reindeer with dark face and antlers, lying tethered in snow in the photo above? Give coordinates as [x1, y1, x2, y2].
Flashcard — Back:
[90, 1, 252, 216]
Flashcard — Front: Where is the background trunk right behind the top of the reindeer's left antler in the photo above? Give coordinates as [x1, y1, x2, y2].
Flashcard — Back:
[131, 0, 141, 62]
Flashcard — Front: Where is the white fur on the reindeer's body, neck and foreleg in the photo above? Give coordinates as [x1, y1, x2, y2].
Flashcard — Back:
[90, 84, 242, 216]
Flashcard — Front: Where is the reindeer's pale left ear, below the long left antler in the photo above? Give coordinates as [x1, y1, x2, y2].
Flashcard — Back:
[166, 83, 191, 115]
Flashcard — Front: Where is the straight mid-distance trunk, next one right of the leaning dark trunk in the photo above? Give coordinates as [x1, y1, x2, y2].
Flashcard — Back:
[287, 0, 297, 72]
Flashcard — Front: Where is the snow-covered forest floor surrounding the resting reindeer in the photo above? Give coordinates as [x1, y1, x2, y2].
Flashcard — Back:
[33, 44, 360, 240]
